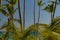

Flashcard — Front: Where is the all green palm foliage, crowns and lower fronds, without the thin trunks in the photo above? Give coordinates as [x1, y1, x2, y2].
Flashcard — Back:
[0, 0, 60, 40]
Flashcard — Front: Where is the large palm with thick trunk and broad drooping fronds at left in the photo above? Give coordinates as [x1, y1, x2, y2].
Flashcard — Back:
[0, 0, 17, 40]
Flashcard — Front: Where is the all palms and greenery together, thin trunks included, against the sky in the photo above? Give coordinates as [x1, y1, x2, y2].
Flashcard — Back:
[0, 0, 60, 40]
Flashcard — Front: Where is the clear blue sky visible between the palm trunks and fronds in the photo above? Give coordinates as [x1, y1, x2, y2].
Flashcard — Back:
[0, 0, 60, 27]
